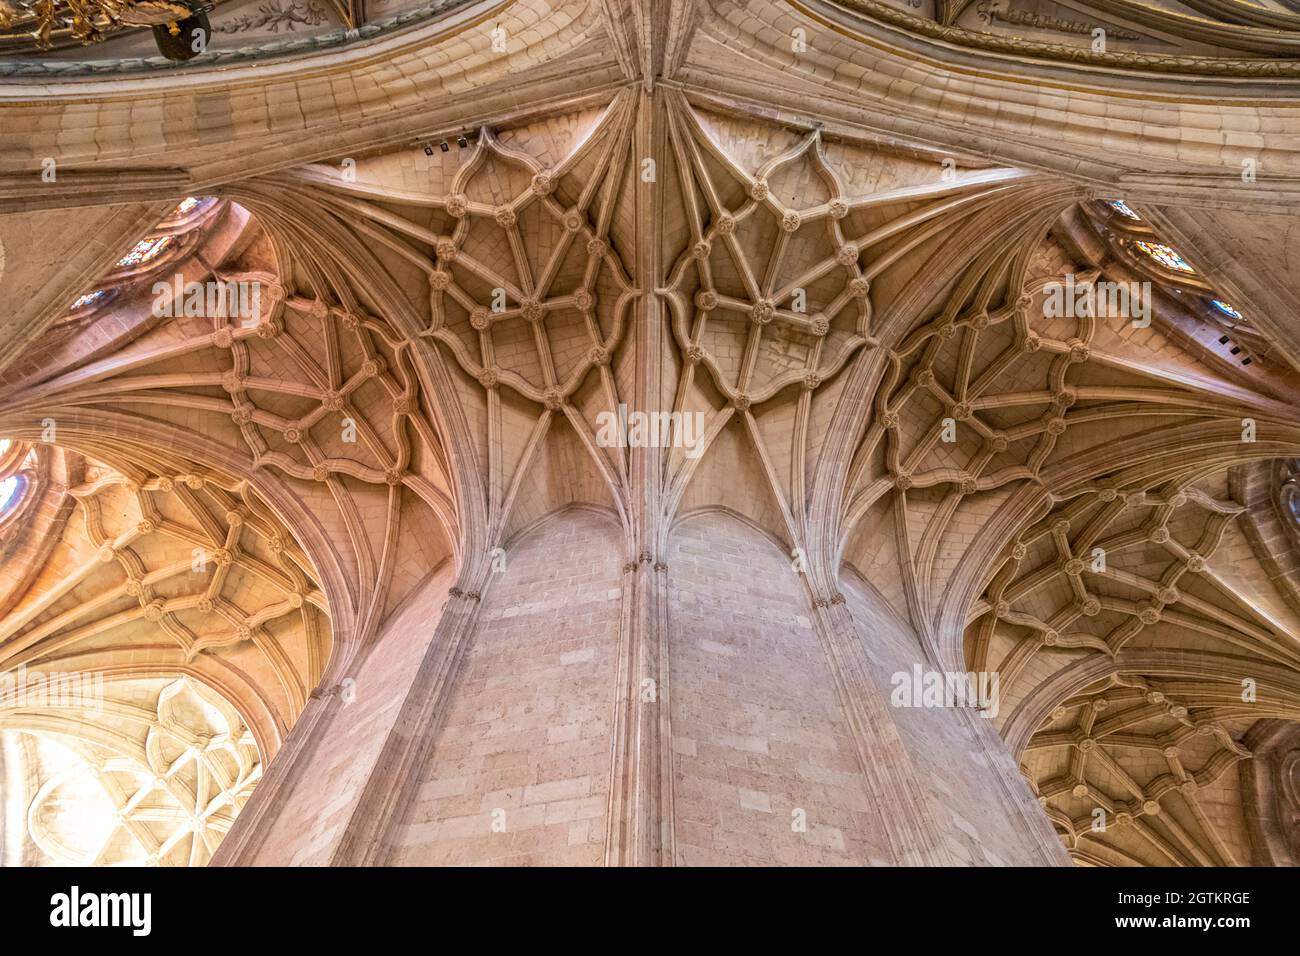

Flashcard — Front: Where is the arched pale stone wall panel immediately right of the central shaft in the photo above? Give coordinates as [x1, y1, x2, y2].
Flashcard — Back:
[668, 512, 887, 866]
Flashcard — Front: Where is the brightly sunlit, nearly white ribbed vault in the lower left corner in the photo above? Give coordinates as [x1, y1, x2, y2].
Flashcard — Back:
[0, 676, 261, 866]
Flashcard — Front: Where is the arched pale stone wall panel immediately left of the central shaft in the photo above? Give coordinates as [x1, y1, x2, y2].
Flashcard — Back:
[393, 510, 624, 866]
